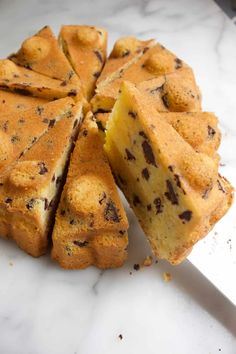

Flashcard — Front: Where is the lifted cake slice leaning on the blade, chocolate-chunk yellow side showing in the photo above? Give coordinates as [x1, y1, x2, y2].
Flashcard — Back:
[105, 82, 233, 264]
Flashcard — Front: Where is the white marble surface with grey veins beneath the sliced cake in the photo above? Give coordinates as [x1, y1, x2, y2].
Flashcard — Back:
[0, 0, 236, 354]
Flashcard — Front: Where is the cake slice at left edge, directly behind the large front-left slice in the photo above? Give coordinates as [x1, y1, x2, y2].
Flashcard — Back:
[0, 97, 74, 174]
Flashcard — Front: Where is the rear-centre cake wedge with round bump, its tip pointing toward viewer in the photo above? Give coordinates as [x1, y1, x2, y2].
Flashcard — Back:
[59, 26, 107, 99]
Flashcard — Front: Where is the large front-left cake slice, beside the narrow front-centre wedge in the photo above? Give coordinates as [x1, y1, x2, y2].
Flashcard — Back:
[0, 103, 82, 257]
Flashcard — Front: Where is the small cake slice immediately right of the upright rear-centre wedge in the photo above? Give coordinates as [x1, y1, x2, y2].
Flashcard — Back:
[96, 37, 155, 90]
